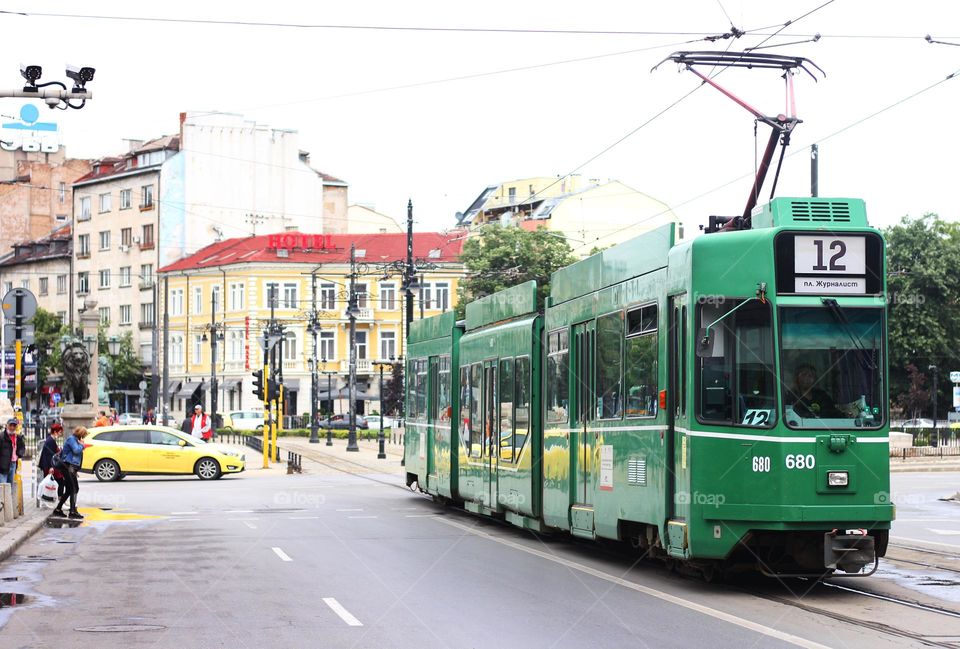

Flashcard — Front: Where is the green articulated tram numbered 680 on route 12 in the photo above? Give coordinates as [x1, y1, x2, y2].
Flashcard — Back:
[405, 198, 894, 576]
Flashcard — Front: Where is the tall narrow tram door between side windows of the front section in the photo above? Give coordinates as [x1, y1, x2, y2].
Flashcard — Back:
[570, 321, 597, 536]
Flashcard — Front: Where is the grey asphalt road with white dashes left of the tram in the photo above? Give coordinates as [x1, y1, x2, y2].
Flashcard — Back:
[0, 464, 960, 649]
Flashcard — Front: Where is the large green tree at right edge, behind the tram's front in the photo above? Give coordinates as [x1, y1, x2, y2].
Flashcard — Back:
[885, 214, 960, 417]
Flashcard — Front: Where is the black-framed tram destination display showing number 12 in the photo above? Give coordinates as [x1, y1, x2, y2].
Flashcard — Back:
[775, 232, 883, 295]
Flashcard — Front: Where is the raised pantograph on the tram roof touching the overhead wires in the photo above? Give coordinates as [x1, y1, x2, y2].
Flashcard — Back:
[651, 51, 826, 230]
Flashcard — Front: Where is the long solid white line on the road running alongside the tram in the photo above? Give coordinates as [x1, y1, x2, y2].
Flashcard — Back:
[437, 518, 827, 649]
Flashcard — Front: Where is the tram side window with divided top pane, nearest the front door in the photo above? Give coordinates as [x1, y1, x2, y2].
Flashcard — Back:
[624, 304, 658, 417]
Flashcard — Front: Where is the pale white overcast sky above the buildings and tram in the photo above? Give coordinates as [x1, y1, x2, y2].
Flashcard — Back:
[0, 0, 960, 251]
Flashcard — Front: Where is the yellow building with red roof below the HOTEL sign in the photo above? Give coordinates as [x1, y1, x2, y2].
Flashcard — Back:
[158, 232, 464, 418]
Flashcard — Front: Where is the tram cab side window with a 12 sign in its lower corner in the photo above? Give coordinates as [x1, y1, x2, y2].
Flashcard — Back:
[696, 300, 776, 428]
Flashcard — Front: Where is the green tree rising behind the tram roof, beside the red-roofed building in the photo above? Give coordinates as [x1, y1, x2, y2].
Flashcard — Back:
[457, 225, 576, 318]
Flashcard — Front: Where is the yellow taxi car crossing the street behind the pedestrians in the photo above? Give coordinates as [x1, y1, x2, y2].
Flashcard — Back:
[80, 425, 246, 482]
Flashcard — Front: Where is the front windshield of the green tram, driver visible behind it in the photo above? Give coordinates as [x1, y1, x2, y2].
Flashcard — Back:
[780, 302, 884, 430]
